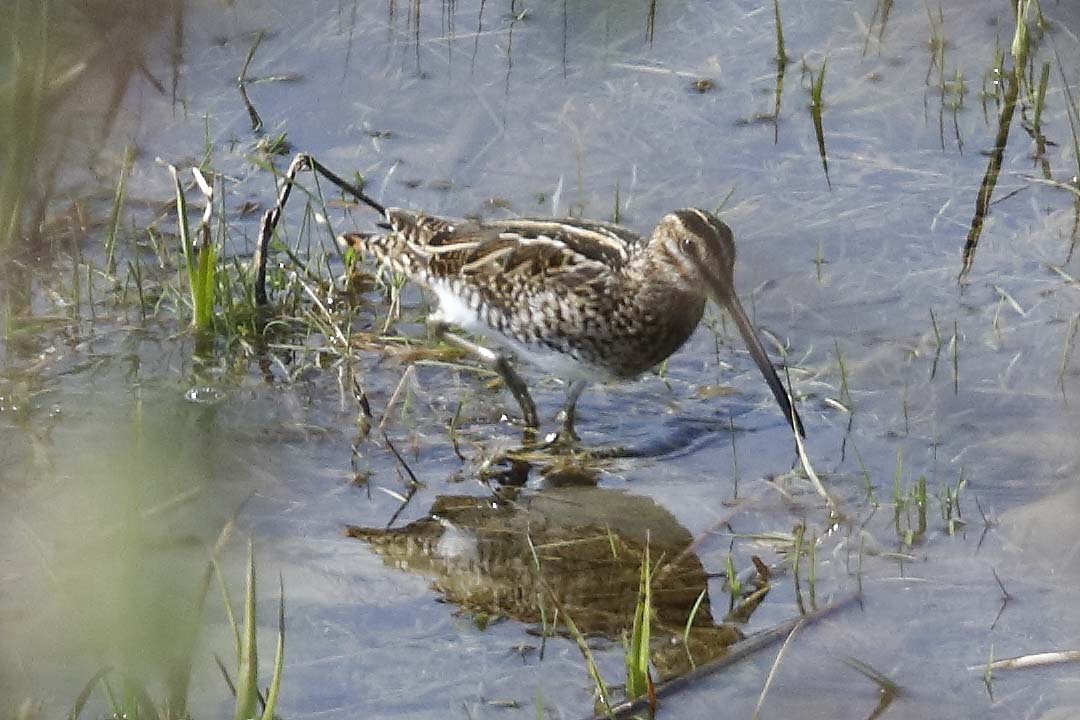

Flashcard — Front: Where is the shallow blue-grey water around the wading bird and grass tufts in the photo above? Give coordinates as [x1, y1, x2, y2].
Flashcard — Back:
[0, 0, 1080, 718]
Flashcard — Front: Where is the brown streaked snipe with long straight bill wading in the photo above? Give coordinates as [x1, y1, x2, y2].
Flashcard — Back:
[339, 199, 806, 439]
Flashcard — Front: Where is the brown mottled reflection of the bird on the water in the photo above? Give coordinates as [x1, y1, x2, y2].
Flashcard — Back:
[347, 487, 742, 677]
